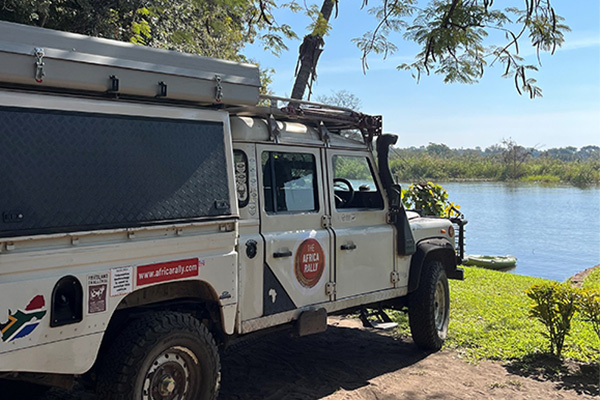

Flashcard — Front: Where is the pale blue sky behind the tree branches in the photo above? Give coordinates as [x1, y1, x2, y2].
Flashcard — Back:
[244, 0, 600, 150]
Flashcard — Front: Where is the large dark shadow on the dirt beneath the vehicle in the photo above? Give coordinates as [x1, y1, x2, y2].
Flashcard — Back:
[219, 326, 428, 400]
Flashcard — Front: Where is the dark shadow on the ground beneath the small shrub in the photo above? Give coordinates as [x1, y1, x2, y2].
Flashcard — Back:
[505, 354, 600, 396]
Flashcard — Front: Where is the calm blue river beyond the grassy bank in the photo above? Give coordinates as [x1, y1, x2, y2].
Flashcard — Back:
[438, 182, 600, 281]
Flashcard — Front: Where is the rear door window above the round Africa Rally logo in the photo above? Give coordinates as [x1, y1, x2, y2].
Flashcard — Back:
[261, 152, 319, 212]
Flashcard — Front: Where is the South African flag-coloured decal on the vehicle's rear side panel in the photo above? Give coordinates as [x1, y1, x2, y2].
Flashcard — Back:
[0, 295, 46, 342]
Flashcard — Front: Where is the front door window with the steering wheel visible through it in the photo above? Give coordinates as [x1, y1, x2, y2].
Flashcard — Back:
[333, 156, 383, 210]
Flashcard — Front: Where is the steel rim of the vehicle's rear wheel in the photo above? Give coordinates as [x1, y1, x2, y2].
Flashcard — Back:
[142, 346, 201, 400]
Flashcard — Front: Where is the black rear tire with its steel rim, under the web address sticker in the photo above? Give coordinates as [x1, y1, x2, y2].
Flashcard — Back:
[97, 312, 221, 400]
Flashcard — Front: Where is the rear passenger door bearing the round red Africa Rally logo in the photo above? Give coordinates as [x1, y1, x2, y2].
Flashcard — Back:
[257, 145, 331, 315]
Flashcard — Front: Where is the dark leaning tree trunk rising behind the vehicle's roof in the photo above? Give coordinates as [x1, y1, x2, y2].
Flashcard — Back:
[291, 0, 337, 100]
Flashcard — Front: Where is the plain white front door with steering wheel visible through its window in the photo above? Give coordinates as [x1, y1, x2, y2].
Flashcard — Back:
[327, 149, 395, 299]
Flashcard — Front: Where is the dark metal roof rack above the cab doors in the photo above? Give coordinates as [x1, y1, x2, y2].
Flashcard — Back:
[228, 95, 382, 144]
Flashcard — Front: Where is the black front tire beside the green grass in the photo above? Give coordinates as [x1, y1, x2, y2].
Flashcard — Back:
[408, 261, 450, 351]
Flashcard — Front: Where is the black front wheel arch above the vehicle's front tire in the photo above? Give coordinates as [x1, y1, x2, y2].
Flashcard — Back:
[408, 238, 463, 293]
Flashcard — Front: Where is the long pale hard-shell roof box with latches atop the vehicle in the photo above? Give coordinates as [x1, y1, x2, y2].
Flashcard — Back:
[0, 21, 260, 105]
